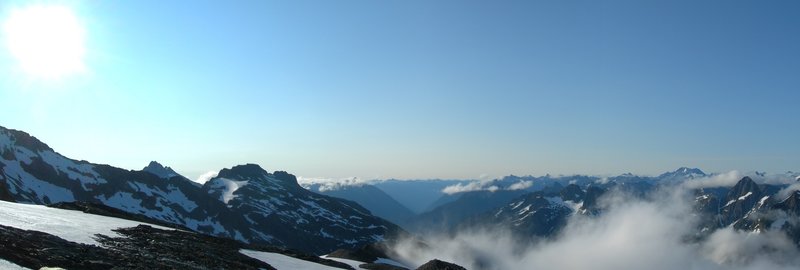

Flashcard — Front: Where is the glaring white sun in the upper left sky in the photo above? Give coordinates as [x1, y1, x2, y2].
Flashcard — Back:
[3, 5, 86, 79]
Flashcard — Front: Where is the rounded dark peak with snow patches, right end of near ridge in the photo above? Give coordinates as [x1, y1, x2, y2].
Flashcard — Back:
[203, 164, 401, 254]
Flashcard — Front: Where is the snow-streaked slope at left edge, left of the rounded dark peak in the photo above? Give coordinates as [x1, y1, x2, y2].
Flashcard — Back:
[0, 127, 233, 236]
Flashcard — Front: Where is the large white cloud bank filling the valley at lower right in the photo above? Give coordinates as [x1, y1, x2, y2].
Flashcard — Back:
[395, 186, 800, 270]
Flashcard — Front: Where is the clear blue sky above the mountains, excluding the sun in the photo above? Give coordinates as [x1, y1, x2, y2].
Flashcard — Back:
[0, 1, 800, 179]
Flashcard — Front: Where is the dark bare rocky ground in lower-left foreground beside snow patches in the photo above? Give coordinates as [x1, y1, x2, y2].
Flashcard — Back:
[0, 225, 352, 269]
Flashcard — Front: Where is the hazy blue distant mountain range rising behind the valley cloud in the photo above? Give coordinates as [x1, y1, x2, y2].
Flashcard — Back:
[310, 167, 800, 247]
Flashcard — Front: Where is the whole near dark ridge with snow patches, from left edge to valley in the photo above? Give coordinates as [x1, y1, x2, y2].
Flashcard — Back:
[0, 127, 398, 254]
